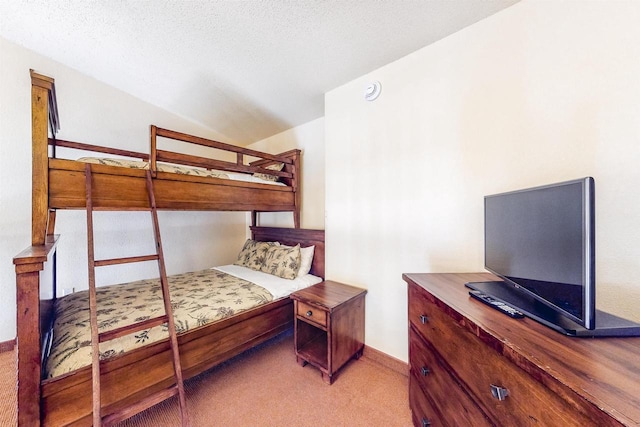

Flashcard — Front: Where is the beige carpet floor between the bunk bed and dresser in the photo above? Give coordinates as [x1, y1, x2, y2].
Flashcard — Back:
[0, 333, 411, 427]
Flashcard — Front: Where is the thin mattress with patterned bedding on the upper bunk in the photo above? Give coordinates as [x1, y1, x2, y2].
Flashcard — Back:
[78, 157, 285, 186]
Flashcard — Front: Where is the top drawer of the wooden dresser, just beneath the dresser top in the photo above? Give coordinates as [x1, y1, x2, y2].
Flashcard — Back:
[409, 286, 593, 426]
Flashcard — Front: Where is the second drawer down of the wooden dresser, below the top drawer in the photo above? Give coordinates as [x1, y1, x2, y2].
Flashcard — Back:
[409, 330, 491, 426]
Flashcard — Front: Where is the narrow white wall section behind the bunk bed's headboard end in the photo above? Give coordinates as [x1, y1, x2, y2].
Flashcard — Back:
[249, 118, 325, 230]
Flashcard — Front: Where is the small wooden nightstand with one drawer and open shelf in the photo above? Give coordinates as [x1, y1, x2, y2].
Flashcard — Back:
[291, 280, 367, 384]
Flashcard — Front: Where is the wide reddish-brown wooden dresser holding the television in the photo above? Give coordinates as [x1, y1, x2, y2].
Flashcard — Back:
[402, 273, 640, 426]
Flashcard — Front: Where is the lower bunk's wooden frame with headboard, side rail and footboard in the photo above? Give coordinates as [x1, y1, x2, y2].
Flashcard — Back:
[14, 227, 324, 426]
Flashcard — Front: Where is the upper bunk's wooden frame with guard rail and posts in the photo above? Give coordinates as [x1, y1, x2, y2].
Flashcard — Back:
[31, 70, 301, 245]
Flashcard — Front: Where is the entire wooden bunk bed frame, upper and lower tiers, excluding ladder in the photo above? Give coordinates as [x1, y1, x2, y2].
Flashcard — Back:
[14, 72, 324, 426]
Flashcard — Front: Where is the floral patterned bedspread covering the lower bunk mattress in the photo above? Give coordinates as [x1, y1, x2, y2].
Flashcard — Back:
[44, 269, 273, 378]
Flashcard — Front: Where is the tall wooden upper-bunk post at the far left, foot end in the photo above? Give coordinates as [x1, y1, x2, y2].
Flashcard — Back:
[31, 70, 56, 245]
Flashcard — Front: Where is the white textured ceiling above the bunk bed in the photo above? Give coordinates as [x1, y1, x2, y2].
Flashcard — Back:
[0, 0, 519, 144]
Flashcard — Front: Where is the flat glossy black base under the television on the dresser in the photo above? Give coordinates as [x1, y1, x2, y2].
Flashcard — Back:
[465, 281, 640, 337]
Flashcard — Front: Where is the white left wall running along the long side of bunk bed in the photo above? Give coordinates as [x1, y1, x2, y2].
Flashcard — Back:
[0, 38, 246, 342]
